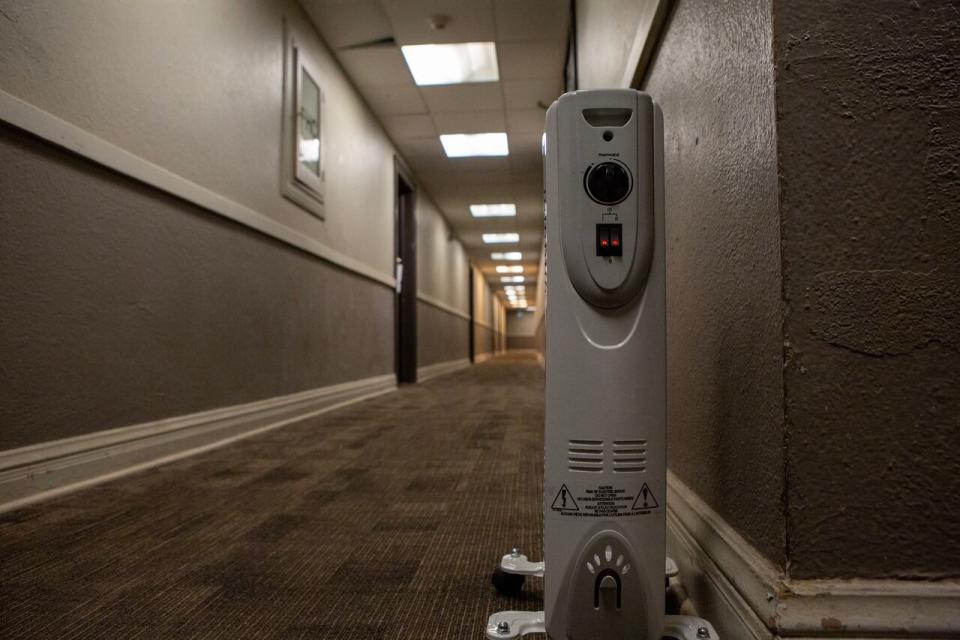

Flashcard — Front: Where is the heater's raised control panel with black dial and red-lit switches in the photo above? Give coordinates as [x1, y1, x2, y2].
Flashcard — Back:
[547, 91, 655, 309]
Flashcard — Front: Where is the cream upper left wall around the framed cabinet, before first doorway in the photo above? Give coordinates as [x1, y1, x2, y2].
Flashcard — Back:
[0, 0, 394, 276]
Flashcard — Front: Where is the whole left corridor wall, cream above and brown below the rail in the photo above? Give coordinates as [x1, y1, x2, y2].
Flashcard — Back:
[0, 0, 495, 449]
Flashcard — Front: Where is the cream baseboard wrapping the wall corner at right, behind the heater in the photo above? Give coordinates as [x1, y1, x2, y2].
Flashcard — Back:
[667, 473, 960, 640]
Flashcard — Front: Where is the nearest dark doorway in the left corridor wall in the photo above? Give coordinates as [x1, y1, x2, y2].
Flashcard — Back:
[394, 159, 417, 384]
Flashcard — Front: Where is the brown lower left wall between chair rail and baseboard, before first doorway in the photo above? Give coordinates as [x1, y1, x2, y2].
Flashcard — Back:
[0, 125, 394, 450]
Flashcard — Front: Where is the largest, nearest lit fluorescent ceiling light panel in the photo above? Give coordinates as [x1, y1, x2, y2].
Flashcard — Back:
[400, 42, 500, 87]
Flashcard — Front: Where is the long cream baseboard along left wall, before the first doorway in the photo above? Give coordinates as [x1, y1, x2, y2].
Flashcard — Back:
[0, 374, 396, 512]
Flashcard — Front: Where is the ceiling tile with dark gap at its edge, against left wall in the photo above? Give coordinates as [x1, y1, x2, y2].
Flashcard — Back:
[300, 0, 393, 49]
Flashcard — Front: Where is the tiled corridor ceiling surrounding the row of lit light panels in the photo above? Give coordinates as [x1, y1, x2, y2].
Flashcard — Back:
[300, 0, 569, 304]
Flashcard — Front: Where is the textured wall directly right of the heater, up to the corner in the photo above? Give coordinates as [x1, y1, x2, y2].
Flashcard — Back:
[645, 0, 785, 565]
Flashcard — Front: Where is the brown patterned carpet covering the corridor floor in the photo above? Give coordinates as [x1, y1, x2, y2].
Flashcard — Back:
[0, 357, 543, 640]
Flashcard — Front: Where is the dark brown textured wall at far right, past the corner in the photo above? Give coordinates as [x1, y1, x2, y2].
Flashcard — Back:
[774, 0, 960, 578]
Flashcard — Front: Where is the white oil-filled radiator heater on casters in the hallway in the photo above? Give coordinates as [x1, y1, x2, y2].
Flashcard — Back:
[486, 89, 717, 640]
